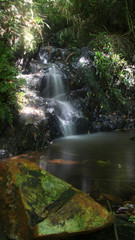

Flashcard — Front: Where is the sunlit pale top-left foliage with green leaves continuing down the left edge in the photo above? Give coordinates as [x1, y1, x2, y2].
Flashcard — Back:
[0, 0, 43, 129]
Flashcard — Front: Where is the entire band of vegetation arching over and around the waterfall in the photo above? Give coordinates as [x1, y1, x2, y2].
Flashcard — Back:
[0, 0, 135, 133]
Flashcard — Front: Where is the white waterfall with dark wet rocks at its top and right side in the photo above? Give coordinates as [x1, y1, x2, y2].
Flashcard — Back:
[39, 47, 88, 137]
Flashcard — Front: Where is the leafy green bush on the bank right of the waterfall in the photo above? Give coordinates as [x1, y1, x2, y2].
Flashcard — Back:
[94, 38, 133, 109]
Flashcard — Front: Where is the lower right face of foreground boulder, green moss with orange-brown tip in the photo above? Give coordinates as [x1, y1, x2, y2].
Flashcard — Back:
[37, 193, 108, 236]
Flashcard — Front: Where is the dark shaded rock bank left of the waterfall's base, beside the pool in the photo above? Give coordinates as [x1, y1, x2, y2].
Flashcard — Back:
[0, 112, 50, 158]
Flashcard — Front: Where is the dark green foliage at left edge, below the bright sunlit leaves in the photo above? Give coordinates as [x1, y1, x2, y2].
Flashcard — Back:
[0, 41, 18, 124]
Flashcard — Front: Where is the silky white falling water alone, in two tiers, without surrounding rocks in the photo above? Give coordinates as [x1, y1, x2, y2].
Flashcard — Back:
[43, 64, 79, 136]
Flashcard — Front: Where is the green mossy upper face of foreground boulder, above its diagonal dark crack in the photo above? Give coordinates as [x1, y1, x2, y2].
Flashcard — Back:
[15, 163, 74, 226]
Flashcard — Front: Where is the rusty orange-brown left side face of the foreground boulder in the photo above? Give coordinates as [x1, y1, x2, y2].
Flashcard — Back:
[0, 160, 33, 239]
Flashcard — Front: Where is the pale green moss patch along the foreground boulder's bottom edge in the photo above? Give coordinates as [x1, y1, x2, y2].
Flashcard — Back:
[38, 203, 108, 236]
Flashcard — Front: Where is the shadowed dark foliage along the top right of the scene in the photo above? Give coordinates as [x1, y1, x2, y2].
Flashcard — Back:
[47, 0, 135, 44]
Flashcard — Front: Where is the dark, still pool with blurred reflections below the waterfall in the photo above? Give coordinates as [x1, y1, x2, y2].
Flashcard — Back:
[33, 132, 135, 200]
